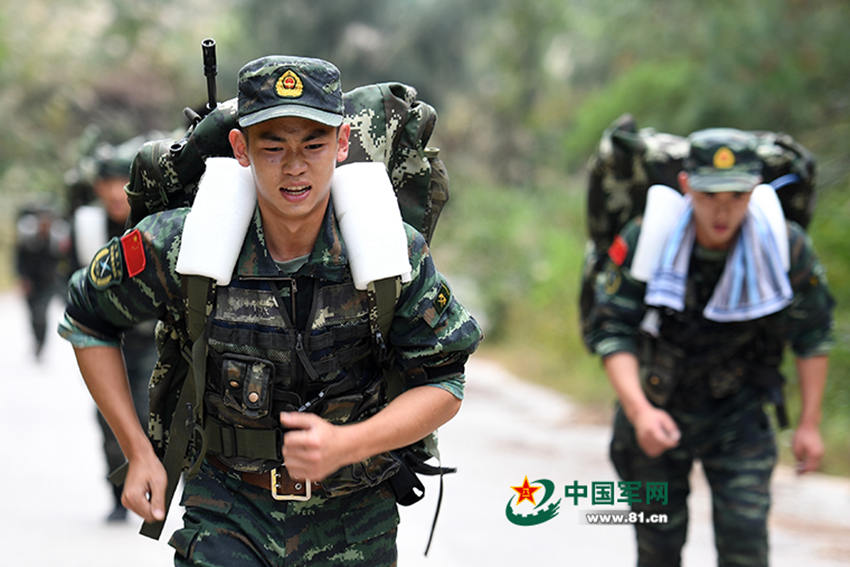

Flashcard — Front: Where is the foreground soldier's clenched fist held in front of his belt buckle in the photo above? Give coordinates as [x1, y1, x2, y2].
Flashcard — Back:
[280, 412, 347, 481]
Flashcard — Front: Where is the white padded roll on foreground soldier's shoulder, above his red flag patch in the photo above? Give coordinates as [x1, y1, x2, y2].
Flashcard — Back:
[177, 158, 257, 285]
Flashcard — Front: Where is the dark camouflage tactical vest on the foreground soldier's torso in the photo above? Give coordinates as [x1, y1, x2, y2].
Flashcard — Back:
[204, 277, 399, 496]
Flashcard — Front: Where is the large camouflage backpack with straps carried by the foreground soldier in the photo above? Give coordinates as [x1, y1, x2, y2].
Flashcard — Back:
[119, 83, 454, 554]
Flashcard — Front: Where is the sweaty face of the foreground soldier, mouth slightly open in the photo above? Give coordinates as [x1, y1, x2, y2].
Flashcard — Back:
[230, 116, 351, 226]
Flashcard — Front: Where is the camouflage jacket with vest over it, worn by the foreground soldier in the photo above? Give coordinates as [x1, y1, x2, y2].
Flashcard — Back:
[60, 203, 481, 491]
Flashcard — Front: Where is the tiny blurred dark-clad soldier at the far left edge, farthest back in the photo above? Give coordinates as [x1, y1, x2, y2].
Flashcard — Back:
[15, 205, 70, 360]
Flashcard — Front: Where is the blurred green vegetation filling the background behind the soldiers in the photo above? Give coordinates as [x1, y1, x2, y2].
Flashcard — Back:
[0, 0, 850, 475]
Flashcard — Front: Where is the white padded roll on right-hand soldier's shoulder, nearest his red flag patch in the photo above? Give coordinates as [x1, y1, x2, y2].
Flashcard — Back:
[631, 185, 686, 282]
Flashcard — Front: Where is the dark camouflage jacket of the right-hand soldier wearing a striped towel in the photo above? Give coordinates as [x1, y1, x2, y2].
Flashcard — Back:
[585, 218, 834, 408]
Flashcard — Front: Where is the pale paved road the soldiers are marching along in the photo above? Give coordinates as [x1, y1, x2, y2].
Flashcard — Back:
[0, 294, 850, 567]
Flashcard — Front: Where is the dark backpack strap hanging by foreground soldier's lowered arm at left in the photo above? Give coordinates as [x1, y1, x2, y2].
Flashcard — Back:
[139, 275, 215, 539]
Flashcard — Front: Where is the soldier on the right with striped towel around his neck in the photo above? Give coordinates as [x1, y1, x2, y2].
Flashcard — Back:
[585, 129, 833, 567]
